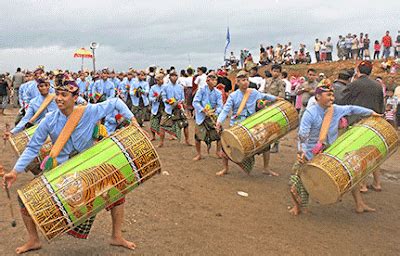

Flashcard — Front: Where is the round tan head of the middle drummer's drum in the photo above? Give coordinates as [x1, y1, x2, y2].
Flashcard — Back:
[221, 130, 245, 163]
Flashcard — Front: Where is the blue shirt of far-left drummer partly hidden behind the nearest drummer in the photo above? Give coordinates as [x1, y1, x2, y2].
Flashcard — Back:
[11, 95, 57, 134]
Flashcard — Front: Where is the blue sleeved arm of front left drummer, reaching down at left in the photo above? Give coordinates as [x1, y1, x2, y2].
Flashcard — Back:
[14, 117, 49, 173]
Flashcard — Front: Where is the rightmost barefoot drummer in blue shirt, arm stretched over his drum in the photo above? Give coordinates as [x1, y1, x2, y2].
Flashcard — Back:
[290, 80, 381, 215]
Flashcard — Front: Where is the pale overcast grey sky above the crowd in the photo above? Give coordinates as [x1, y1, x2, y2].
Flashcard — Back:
[0, 0, 400, 73]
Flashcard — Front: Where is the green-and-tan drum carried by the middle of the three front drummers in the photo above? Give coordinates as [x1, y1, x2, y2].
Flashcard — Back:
[221, 100, 299, 163]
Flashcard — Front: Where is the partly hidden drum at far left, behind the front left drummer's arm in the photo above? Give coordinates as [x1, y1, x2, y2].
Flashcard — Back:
[9, 125, 52, 175]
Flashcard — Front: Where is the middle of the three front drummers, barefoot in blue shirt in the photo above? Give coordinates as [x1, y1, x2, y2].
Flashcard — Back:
[216, 71, 280, 176]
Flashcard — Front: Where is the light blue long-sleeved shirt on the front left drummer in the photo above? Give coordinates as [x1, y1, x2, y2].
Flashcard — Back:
[14, 98, 133, 173]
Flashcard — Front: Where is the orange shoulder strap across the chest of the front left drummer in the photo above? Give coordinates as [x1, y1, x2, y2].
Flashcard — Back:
[49, 106, 86, 159]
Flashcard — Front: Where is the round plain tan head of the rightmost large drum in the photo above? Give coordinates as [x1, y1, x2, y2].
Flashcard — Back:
[300, 164, 340, 204]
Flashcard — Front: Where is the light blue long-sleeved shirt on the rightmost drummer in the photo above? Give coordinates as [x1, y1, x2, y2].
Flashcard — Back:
[298, 104, 373, 160]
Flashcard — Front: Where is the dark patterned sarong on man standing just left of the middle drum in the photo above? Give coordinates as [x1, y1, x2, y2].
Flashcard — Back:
[194, 116, 220, 150]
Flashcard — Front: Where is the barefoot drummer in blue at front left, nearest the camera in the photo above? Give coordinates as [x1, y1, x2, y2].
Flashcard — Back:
[3, 81, 137, 254]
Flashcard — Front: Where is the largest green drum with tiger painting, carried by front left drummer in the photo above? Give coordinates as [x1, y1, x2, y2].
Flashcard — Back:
[18, 126, 161, 240]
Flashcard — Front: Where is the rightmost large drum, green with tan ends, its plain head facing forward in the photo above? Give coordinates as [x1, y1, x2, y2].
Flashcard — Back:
[300, 117, 399, 204]
